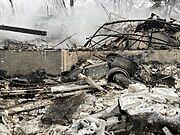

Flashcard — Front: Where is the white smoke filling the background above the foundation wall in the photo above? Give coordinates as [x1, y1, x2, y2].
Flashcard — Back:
[0, 0, 179, 46]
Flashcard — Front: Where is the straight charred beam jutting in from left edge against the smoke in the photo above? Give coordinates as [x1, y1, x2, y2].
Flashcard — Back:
[0, 25, 47, 36]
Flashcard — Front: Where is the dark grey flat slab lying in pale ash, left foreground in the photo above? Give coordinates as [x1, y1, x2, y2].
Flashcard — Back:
[41, 92, 85, 125]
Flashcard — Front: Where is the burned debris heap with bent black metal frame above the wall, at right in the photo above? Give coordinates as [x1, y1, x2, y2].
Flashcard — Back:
[84, 13, 180, 51]
